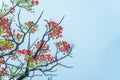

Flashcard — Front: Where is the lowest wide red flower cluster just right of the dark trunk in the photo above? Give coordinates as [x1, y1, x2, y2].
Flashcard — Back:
[39, 53, 54, 63]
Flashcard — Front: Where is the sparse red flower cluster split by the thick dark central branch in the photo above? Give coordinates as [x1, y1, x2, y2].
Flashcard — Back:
[34, 40, 49, 53]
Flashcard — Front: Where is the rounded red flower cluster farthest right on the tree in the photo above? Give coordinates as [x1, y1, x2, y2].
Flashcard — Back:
[56, 41, 70, 54]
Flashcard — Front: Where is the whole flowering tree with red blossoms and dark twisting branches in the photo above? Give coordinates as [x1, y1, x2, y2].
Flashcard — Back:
[0, 0, 73, 80]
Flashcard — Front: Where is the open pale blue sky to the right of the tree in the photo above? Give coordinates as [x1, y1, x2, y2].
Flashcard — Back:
[1, 0, 120, 80]
